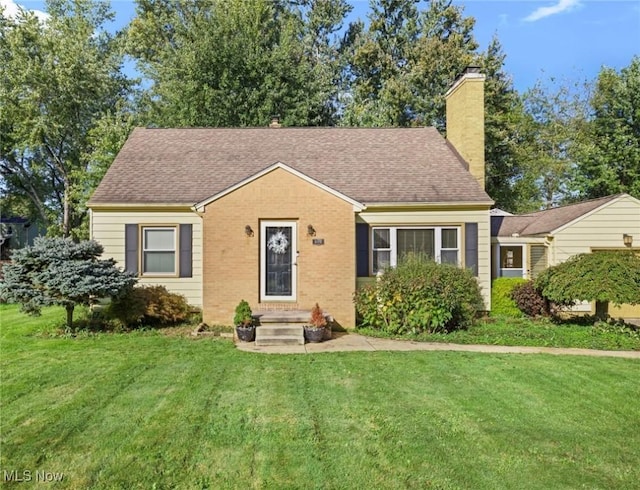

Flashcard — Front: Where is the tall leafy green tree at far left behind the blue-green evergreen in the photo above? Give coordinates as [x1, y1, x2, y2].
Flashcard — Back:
[0, 0, 130, 236]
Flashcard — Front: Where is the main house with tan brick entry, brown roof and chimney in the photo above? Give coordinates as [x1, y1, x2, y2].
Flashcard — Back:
[89, 70, 493, 327]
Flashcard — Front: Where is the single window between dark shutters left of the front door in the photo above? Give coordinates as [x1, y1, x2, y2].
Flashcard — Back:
[142, 227, 177, 275]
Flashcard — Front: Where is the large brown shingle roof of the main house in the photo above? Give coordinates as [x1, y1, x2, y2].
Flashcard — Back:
[90, 128, 491, 204]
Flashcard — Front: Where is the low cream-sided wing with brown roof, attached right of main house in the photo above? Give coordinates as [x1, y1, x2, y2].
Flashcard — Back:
[491, 194, 640, 318]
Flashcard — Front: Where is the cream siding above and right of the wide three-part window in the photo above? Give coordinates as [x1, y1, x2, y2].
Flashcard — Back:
[358, 209, 491, 310]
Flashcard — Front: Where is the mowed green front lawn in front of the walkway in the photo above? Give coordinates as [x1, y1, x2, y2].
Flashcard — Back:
[0, 305, 640, 489]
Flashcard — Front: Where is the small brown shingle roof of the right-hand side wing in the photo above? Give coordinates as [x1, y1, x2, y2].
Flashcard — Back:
[491, 194, 626, 236]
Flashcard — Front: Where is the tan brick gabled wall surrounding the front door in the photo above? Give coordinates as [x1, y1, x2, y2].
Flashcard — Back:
[203, 168, 356, 327]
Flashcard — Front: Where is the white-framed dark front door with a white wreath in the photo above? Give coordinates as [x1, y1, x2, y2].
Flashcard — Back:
[260, 221, 297, 301]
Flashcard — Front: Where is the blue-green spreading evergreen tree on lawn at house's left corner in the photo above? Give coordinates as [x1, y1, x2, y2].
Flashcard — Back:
[0, 237, 136, 328]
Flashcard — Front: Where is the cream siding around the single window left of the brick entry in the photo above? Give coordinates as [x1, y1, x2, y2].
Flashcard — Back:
[91, 209, 202, 307]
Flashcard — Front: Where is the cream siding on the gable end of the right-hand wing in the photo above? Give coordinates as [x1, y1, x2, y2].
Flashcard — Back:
[549, 196, 640, 265]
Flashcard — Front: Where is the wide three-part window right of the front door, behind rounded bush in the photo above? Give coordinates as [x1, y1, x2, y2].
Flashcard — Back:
[372, 227, 460, 274]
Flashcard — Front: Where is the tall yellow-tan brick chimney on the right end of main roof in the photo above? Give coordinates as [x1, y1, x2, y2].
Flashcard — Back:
[445, 66, 486, 189]
